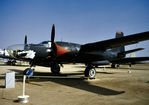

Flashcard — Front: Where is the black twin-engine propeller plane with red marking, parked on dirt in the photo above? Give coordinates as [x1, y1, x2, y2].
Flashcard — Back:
[0, 24, 149, 78]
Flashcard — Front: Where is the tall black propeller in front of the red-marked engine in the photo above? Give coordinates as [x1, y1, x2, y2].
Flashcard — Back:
[51, 24, 57, 58]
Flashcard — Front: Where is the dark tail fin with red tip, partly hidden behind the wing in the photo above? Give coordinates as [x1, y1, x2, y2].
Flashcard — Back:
[115, 31, 125, 57]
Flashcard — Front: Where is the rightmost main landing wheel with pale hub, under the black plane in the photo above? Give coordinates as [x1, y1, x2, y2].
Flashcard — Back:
[84, 66, 96, 78]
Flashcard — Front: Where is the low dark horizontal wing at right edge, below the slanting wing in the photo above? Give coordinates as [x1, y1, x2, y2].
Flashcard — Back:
[111, 57, 149, 64]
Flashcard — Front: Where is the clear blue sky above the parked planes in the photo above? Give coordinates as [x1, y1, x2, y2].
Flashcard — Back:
[0, 0, 149, 56]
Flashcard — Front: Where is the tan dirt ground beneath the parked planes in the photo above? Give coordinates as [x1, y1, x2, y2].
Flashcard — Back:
[0, 63, 149, 105]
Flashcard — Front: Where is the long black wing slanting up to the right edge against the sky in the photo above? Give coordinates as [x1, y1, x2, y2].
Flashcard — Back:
[80, 31, 149, 52]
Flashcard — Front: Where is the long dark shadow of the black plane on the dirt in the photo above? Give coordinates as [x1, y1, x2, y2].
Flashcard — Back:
[6, 69, 125, 96]
